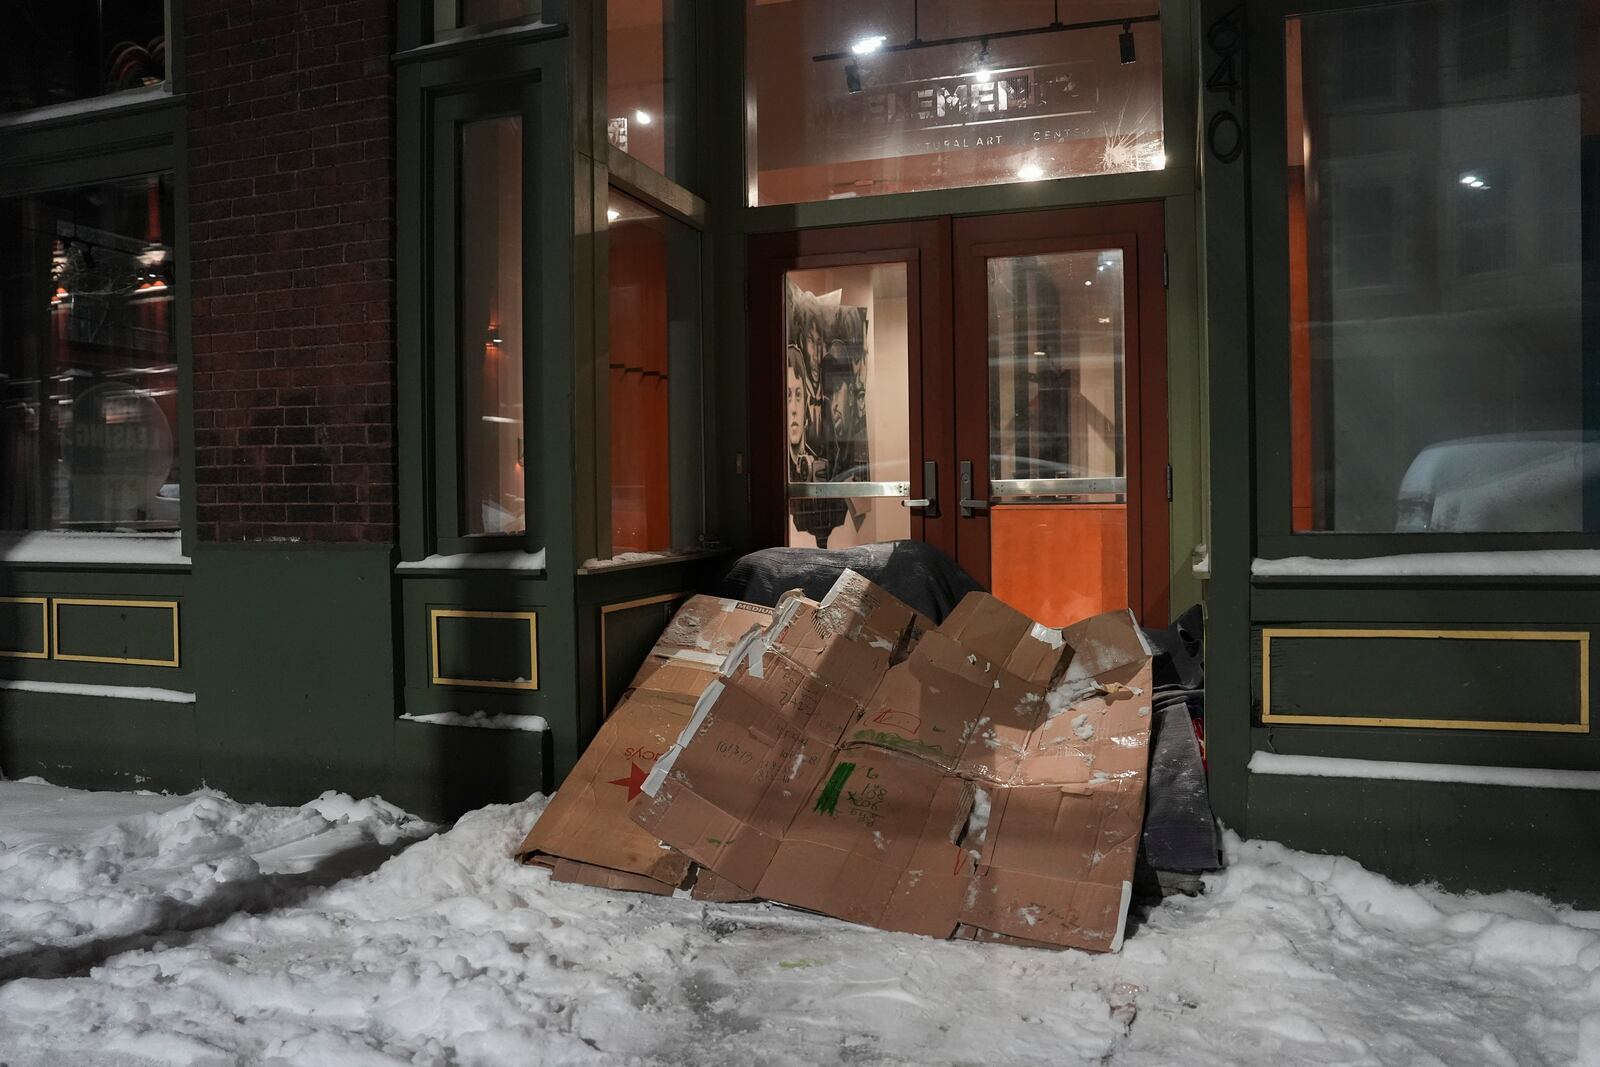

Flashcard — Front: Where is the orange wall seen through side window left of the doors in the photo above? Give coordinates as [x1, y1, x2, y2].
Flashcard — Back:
[610, 222, 672, 552]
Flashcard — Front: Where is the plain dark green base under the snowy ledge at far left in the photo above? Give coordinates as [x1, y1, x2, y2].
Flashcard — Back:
[0, 689, 201, 800]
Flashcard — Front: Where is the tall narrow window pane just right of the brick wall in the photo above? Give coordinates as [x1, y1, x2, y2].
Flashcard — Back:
[461, 117, 528, 534]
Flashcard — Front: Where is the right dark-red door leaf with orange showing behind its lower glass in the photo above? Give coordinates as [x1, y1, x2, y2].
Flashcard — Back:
[955, 205, 1168, 625]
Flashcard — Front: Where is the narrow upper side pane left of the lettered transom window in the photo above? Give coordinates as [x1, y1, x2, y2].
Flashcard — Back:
[606, 0, 693, 182]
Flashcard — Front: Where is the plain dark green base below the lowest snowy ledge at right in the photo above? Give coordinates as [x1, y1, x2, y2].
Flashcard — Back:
[1250, 774, 1600, 907]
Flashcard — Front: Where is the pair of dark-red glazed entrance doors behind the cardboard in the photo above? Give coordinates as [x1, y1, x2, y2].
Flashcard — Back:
[750, 205, 1166, 624]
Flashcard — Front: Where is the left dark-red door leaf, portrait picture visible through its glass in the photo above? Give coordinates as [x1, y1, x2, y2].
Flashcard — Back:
[749, 221, 955, 555]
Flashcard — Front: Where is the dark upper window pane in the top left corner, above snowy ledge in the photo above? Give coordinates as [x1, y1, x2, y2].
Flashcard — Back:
[0, 0, 166, 112]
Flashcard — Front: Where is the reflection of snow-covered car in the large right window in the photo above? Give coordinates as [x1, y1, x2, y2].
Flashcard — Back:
[1395, 432, 1600, 533]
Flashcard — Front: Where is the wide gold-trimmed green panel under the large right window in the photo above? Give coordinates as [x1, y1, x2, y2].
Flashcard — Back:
[1262, 630, 1587, 728]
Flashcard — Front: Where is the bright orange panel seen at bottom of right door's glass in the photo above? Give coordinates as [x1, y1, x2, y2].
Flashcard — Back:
[989, 504, 1128, 625]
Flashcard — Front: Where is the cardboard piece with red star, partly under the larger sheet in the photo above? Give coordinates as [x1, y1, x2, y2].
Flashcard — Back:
[517, 597, 773, 901]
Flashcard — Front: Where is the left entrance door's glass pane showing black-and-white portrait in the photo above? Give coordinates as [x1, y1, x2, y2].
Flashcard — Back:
[781, 262, 910, 549]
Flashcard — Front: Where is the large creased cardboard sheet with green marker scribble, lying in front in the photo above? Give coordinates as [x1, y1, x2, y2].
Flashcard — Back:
[632, 573, 1152, 950]
